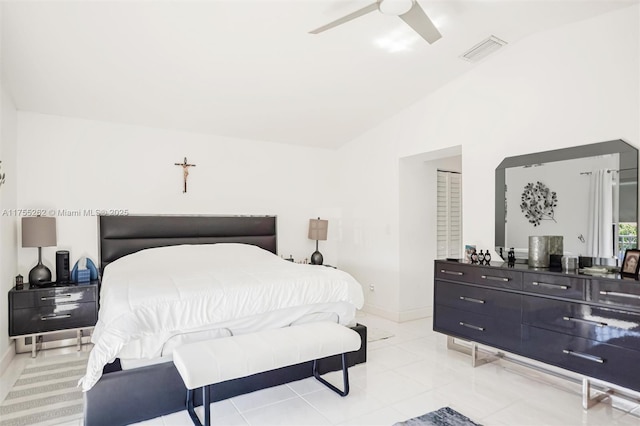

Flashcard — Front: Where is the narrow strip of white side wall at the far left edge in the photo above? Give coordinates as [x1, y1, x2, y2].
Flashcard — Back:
[0, 88, 18, 373]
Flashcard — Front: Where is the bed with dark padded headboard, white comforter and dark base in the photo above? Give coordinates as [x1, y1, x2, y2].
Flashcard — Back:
[83, 216, 366, 426]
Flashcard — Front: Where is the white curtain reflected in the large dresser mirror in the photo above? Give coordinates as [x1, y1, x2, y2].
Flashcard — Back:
[587, 170, 613, 257]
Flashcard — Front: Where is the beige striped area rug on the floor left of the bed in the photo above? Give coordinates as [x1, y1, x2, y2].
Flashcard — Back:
[0, 352, 88, 426]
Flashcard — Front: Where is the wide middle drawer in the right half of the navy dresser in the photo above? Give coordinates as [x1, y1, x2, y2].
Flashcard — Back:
[522, 296, 640, 351]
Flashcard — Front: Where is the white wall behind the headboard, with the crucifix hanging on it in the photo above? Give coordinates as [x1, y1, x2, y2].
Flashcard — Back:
[17, 112, 340, 276]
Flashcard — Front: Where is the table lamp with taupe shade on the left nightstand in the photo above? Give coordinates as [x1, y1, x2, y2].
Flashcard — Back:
[22, 216, 56, 285]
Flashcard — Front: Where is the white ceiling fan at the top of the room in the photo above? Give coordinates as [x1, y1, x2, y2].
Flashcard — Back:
[309, 0, 442, 44]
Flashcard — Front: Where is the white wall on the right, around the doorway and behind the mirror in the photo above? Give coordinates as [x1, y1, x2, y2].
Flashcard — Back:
[339, 5, 640, 319]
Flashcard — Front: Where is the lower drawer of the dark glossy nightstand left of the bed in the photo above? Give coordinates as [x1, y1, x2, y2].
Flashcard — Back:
[10, 302, 98, 336]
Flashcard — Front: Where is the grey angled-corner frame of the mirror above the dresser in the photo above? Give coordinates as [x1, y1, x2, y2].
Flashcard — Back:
[495, 139, 638, 260]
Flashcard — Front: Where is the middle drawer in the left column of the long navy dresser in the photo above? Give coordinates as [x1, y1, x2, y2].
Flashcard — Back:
[435, 281, 522, 322]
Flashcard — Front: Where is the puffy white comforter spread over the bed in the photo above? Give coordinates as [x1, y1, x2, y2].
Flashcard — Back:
[80, 244, 364, 391]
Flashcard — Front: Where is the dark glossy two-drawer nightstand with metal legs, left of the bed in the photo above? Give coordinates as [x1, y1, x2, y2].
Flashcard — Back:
[9, 281, 98, 357]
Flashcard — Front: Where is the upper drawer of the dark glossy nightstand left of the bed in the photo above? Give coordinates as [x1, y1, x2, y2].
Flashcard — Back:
[11, 286, 96, 309]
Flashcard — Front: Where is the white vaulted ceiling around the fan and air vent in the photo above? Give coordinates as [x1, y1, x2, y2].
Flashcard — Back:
[1, 0, 637, 148]
